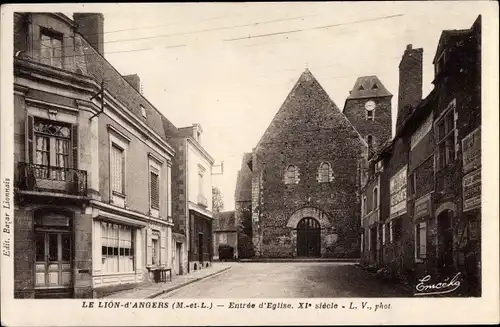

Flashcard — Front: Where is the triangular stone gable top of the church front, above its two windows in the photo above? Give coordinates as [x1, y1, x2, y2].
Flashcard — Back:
[256, 70, 364, 151]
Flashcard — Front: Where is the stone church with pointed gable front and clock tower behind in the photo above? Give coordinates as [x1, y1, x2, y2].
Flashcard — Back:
[237, 69, 392, 258]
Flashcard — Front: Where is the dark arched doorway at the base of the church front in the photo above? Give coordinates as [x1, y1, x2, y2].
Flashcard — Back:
[297, 217, 321, 257]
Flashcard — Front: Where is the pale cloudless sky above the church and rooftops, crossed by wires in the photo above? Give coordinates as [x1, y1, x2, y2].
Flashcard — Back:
[69, 2, 481, 210]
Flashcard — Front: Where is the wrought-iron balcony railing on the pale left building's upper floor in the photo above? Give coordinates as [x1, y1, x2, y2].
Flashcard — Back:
[17, 162, 87, 196]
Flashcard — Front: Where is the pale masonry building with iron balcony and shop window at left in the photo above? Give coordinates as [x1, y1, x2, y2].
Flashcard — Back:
[14, 13, 175, 298]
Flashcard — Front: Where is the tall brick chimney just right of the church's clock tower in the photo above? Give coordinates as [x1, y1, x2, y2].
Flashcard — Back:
[396, 44, 424, 132]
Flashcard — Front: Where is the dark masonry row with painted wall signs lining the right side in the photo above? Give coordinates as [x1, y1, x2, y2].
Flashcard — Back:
[361, 16, 481, 296]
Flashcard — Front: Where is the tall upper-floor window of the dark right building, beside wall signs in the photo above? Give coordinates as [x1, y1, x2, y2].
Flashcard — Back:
[436, 102, 455, 170]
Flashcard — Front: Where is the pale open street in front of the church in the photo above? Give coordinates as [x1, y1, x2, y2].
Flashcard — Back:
[160, 262, 412, 298]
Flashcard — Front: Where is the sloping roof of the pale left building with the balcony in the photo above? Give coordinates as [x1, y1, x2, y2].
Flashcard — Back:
[79, 32, 177, 145]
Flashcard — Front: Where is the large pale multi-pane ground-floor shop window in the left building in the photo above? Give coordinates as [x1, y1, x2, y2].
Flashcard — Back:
[101, 222, 134, 273]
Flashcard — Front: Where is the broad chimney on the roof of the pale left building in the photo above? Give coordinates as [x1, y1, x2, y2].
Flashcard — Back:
[73, 13, 104, 56]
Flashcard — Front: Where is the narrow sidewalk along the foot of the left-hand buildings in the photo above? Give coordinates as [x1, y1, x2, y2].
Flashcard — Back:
[103, 262, 231, 299]
